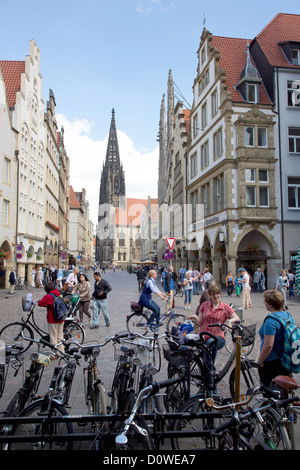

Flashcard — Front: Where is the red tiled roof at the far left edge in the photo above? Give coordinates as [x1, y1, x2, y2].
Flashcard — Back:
[0, 60, 25, 108]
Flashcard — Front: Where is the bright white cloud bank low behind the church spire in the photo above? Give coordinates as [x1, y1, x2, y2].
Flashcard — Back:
[56, 114, 159, 225]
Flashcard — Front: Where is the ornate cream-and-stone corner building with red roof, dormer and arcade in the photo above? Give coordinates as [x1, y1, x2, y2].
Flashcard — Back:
[187, 28, 281, 285]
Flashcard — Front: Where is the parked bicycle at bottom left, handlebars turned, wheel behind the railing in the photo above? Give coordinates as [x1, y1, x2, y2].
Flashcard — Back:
[9, 338, 80, 450]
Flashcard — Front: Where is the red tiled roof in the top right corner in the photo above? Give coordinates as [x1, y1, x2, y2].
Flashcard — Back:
[254, 13, 300, 68]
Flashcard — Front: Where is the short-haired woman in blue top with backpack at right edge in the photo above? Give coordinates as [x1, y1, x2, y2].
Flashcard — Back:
[258, 290, 300, 387]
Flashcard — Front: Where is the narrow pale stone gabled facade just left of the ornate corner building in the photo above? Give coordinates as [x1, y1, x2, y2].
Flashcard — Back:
[157, 70, 190, 269]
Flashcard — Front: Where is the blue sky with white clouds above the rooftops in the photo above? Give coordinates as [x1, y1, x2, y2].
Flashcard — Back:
[0, 0, 300, 221]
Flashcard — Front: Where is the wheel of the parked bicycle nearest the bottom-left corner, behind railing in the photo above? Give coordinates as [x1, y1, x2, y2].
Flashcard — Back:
[9, 399, 73, 450]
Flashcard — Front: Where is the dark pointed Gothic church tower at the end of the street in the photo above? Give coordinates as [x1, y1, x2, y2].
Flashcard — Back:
[95, 109, 126, 264]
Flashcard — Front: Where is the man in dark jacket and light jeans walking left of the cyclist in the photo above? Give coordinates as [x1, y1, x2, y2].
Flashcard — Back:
[91, 271, 111, 328]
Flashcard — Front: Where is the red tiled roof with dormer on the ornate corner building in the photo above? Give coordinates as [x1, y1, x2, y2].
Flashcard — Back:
[212, 36, 271, 104]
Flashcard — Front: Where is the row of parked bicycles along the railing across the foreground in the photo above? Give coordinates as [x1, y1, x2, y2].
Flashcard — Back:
[0, 294, 297, 450]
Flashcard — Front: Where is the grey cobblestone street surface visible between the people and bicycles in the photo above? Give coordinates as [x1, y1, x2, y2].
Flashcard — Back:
[0, 271, 300, 449]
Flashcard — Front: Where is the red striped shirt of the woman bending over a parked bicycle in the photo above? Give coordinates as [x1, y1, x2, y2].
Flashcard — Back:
[200, 300, 234, 339]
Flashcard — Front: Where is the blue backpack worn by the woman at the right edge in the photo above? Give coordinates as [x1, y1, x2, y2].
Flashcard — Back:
[268, 312, 300, 374]
